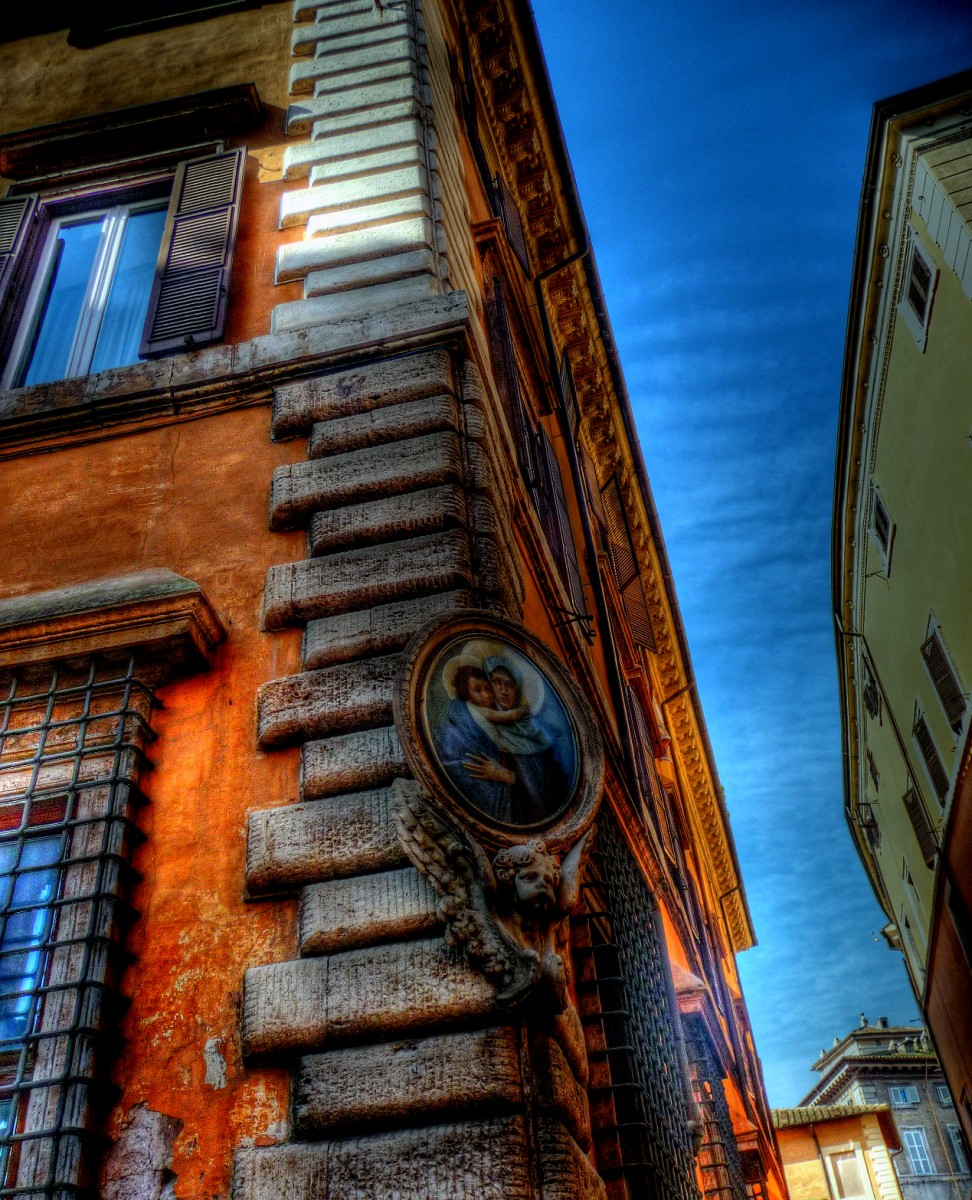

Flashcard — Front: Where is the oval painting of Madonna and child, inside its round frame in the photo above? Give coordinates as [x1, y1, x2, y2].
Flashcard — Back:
[425, 637, 580, 826]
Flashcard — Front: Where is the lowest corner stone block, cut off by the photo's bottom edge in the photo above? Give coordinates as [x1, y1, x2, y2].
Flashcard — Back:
[233, 1117, 530, 1200]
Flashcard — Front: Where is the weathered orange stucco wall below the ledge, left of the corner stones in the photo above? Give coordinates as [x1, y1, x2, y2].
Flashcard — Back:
[0, 407, 305, 1196]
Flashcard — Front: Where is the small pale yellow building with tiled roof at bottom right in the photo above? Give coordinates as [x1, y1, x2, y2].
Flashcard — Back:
[773, 1104, 901, 1200]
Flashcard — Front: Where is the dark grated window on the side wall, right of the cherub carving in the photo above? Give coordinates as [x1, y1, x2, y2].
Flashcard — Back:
[571, 815, 698, 1200]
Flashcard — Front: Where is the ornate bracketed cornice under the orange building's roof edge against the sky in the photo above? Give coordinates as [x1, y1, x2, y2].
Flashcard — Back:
[462, 0, 755, 950]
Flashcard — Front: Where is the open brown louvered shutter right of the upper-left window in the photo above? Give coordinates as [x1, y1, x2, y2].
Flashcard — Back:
[139, 150, 246, 358]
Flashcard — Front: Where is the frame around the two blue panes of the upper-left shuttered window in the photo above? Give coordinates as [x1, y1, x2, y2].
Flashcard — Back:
[0, 190, 172, 388]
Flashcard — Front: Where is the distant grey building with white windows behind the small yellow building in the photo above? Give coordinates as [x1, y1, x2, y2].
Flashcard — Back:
[796, 1014, 972, 1200]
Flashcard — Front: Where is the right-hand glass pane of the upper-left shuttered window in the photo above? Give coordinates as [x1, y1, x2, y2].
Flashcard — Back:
[90, 209, 166, 372]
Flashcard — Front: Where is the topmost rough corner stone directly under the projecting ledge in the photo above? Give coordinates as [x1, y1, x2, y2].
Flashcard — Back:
[274, 350, 455, 437]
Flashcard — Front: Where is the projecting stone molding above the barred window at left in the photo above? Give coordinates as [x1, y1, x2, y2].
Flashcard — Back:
[0, 569, 226, 677]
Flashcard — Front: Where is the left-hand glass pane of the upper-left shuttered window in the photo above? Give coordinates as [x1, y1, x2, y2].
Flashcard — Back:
[19, 217, 104, 386]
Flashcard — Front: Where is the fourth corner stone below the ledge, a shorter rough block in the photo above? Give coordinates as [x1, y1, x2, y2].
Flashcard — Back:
[307, 485, 466, 554]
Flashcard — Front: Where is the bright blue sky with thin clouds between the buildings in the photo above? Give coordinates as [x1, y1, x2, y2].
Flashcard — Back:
[534, 0, 972, 1105]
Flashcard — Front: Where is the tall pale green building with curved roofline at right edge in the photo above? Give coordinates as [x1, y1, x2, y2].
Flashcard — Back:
[833, 72, 972, 1136]
